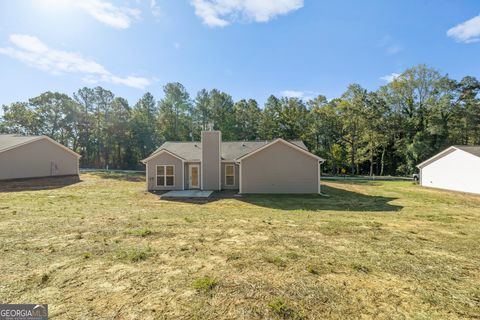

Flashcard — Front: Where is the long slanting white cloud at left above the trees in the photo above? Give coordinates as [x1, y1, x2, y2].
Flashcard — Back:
[0, 34, 152, 90]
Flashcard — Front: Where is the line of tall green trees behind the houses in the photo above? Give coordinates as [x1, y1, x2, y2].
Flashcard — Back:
[0, 65, 480, 175]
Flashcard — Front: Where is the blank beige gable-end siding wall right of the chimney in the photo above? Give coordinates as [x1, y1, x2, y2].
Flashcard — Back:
[240, 142, 320, 193]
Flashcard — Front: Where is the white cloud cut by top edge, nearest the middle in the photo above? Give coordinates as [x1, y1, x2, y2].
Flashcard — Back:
[192, 0, 303, 27]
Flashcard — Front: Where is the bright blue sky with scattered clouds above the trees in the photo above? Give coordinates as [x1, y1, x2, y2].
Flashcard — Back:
[0, 0, 480, 109]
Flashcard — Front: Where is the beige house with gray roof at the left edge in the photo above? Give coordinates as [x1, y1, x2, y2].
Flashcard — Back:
[0, 134, 80, 180]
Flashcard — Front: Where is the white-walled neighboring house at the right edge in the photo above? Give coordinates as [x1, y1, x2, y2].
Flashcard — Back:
[417, 146, 480, 194]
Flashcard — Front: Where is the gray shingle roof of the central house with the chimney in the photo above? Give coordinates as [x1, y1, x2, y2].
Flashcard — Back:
[152, 140, 308, 161]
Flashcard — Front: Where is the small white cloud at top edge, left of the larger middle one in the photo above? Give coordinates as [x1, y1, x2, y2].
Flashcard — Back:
[75, 0, 140, 29]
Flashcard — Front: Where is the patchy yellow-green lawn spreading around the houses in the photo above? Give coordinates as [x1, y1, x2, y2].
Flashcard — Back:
[0, 174, 480, 319]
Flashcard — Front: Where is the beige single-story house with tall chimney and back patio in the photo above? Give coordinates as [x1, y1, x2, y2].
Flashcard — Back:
[142, 131, 324, 193]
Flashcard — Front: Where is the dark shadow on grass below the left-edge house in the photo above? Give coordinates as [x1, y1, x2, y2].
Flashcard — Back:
[0, 176, 81, 193]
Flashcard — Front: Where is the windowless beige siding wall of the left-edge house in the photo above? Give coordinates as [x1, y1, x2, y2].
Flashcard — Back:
[0, 139, 79, 180]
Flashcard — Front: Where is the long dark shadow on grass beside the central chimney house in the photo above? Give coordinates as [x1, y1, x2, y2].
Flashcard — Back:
[155, 185, 402, 212]
